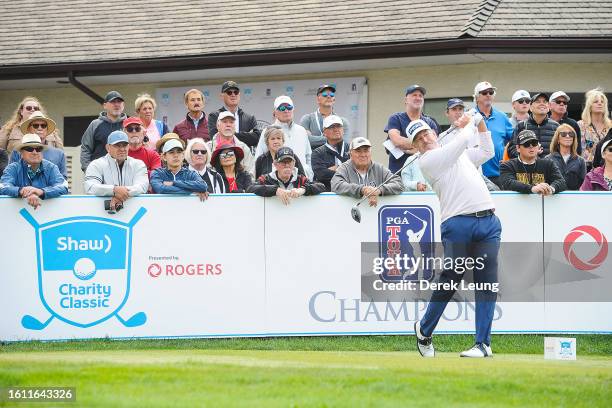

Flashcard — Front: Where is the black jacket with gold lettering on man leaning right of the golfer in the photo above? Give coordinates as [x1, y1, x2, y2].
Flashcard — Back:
[499, 158, 566, 194]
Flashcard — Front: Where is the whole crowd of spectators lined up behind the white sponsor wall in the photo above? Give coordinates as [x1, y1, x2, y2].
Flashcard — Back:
[0, 81, 612, 212]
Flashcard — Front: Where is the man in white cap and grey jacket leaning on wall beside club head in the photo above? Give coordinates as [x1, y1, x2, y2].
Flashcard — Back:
[331, 137, 404, 207]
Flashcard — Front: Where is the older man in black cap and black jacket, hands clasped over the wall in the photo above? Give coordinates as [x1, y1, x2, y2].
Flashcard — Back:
[247, 147, 325, 205]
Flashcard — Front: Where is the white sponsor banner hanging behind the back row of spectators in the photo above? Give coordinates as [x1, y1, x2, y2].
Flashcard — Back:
[155, 77, 368, 138]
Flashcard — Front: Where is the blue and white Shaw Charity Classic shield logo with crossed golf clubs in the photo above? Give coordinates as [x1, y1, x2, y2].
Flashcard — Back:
[20, 208, 147, 330]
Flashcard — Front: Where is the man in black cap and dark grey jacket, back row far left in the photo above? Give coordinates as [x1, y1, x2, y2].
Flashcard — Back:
[81, 91, 127, 172]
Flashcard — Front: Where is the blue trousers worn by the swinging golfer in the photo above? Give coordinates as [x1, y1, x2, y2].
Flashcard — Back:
[421, 215, 501, 345]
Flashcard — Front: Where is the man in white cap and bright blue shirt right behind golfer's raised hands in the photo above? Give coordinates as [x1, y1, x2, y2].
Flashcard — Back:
[469, 81, 513, 186]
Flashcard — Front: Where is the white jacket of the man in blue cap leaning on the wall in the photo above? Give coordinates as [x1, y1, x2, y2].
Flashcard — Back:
[83, 153, 149, 196]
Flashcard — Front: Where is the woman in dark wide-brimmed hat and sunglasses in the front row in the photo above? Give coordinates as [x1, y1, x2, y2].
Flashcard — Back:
[211, 144, 253, 193]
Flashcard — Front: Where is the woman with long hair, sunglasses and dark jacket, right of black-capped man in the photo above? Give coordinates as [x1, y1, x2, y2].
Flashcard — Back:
[547, 124, 586, 190]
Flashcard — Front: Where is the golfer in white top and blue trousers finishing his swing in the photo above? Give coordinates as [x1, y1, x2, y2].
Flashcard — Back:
[406, 114, 501, 357]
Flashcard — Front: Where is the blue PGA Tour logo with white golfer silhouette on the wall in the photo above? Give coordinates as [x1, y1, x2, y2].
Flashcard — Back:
[378, 205, 435, 282]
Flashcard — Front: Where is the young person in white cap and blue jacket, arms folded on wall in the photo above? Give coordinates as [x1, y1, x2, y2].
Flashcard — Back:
[151, 139, 208, 201]
